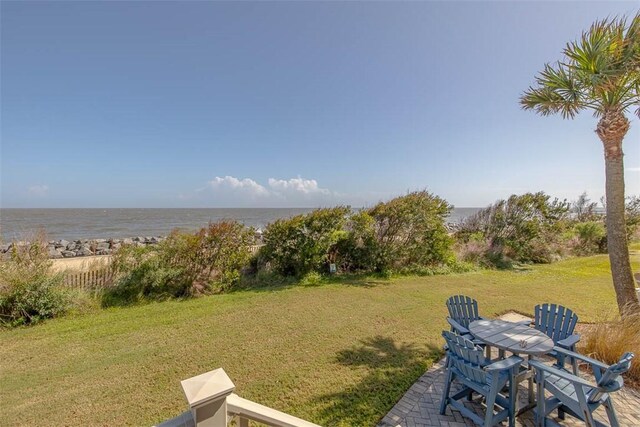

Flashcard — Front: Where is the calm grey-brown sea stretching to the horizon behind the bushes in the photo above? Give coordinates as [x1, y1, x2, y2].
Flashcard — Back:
[0, 208, 479, 241]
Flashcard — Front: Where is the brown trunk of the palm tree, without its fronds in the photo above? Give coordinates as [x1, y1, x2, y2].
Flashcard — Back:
[596, 111, 640, 316]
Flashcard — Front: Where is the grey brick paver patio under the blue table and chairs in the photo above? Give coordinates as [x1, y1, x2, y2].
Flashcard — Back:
[378, 320, 640, 427]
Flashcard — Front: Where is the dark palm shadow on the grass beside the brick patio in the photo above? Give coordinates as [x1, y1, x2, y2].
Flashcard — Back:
[313, 336, 442, 426]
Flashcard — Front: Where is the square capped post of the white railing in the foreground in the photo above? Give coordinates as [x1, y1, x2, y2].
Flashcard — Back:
[180, 368, 236, 427]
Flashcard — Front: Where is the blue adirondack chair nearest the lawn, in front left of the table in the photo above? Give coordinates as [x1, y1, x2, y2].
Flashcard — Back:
[440, 331, 523, 427]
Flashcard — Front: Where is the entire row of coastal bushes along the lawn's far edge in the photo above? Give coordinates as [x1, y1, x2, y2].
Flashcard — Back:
[0, 191, 640, 326]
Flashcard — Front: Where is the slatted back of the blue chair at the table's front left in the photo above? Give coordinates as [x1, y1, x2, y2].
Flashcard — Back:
[442, 331, 491, 384]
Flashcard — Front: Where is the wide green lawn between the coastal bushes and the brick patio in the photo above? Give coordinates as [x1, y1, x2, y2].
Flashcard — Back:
[0, 251, 640, 426]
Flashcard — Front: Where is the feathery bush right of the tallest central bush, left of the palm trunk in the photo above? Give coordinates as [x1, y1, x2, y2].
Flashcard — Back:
[456, 192, 569, 267]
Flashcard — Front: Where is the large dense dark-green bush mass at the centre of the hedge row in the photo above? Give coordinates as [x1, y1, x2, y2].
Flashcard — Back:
[260, 191, 454, 277]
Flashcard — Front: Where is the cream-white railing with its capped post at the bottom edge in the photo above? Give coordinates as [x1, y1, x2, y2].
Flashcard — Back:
[157, 368, 320, 427]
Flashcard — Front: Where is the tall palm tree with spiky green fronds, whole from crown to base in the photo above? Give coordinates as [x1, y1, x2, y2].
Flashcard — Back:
[520, 13, 640, 315]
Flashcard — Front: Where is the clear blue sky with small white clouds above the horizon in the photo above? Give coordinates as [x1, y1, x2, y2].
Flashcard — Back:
[0, 1, 640, 207]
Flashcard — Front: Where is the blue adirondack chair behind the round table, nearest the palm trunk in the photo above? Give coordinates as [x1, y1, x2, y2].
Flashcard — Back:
[533, 304, 580, 375]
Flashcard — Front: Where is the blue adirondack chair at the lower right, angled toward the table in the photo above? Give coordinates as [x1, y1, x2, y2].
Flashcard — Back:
[529, 347, 634, 427]
